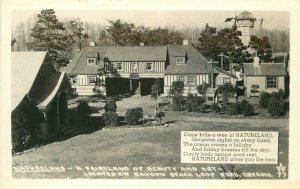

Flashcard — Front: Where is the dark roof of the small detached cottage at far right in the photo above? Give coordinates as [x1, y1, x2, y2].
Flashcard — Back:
[244, 63, 286, 76]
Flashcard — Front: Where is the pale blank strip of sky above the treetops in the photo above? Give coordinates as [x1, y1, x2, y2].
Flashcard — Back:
[11, 9, 290, 29]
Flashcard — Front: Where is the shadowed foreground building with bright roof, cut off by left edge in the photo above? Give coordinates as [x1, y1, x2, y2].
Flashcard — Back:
[11, 52, 69, 151]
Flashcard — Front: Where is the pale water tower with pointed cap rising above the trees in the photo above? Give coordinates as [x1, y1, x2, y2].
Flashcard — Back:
[236, 11, 256, 46]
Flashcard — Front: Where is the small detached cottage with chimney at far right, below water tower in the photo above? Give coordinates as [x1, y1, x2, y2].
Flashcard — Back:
[243, 57, 287, 97]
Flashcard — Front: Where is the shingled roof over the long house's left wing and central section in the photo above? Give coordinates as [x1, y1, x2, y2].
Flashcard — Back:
[66, 46, 167, 75]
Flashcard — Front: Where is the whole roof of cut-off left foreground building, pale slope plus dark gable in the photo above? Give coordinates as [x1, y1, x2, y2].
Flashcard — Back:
[11, 52, 69, 111]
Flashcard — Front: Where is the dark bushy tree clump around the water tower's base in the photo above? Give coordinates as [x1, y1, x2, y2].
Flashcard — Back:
[196, 24, 271, 70]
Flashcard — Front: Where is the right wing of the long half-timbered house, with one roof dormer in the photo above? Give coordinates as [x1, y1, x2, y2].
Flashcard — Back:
[164, 45, 213, 95]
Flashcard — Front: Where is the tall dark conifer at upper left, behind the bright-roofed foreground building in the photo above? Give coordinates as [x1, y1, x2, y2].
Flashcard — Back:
[27, 9, 74, 68]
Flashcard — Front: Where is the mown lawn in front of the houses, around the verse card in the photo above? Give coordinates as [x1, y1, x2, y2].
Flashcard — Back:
[12, 97, 288, 179]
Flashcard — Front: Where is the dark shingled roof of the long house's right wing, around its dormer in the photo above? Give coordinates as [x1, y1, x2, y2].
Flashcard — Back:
[166, 45, 211, 74]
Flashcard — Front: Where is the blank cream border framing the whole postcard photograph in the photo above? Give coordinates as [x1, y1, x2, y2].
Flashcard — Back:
[0, 0, 300, 189]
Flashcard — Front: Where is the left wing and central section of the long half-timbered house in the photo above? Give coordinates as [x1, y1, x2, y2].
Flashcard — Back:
[66, 46, 167, 96]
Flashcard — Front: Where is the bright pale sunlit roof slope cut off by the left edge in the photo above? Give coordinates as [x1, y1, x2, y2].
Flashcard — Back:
[11, 52, 46, 110]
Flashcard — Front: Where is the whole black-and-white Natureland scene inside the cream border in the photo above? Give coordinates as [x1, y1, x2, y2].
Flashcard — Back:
[1, 2, 299, 187]
